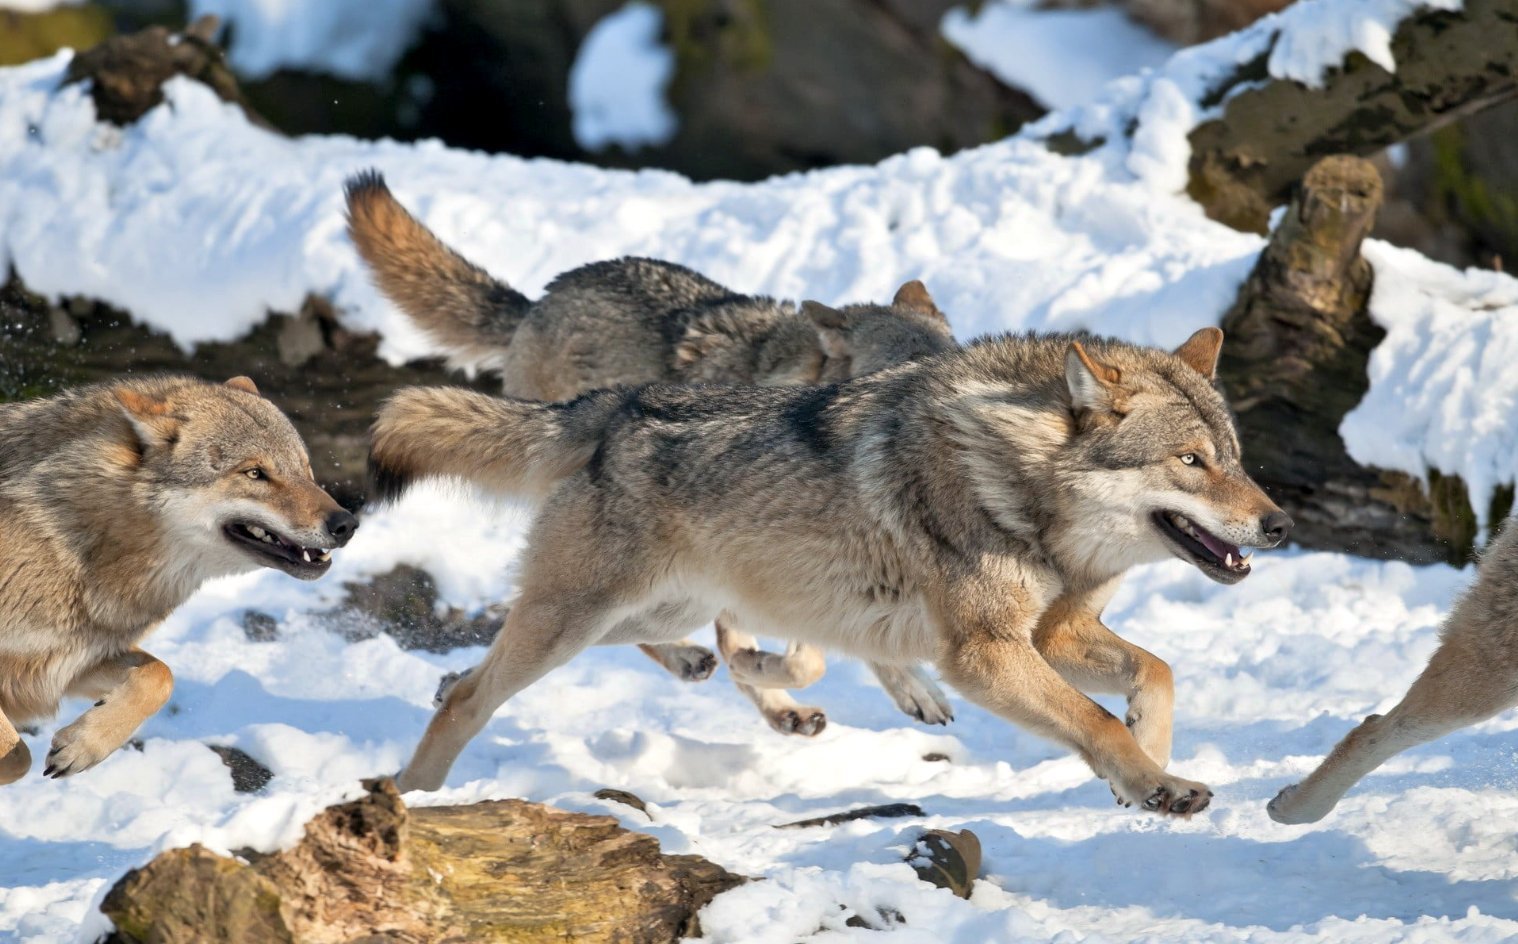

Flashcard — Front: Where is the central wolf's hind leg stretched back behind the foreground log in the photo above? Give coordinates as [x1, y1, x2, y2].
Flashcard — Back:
[395, 592, 609, 792]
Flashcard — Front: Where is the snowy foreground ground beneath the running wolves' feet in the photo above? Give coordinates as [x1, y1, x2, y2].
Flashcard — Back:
[0, 490, 1518, 944]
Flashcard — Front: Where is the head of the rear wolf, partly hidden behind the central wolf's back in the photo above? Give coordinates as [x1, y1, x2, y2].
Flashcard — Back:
[802, 279, 955, 382]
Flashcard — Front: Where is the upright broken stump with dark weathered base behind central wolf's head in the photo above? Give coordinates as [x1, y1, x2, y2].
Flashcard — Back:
[1217, 156, 1510, 563]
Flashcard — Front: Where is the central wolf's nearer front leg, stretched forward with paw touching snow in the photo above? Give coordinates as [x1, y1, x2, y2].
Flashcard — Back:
[938, 584, 1213, 815]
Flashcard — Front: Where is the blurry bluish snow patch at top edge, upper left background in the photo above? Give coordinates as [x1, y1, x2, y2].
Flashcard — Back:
[188, 0, 433, 82]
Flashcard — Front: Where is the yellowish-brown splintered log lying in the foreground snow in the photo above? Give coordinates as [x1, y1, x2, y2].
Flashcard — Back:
[100, 780, 744, 944]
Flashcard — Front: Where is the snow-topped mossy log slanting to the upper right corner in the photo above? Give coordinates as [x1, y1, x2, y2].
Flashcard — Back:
[1187, 0, 1518, 232]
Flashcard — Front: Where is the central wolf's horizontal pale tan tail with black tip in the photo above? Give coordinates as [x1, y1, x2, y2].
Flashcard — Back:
[369, 387, 622, 504]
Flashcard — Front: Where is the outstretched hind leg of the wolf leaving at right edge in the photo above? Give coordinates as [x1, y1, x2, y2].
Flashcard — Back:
[1266, 631, 1518, 824]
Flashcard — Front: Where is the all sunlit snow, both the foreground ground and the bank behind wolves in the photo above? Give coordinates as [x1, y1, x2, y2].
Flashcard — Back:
[0, 0, 1518, 944]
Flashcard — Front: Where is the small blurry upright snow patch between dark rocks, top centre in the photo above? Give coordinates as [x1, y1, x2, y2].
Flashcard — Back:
[569, 3, 679, 152]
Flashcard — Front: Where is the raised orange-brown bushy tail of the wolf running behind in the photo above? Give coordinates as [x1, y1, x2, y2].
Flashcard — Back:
[343, 170, 531, 366]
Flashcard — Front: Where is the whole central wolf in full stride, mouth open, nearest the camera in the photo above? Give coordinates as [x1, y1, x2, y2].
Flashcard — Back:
[370, 328, 1292, 815]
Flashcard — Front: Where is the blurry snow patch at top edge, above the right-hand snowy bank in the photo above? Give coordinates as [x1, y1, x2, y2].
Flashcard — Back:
[941, 0, 1175, 108]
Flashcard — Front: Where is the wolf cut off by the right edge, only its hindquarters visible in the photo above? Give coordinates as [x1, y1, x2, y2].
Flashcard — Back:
[1268, 519, 1518, 824]
